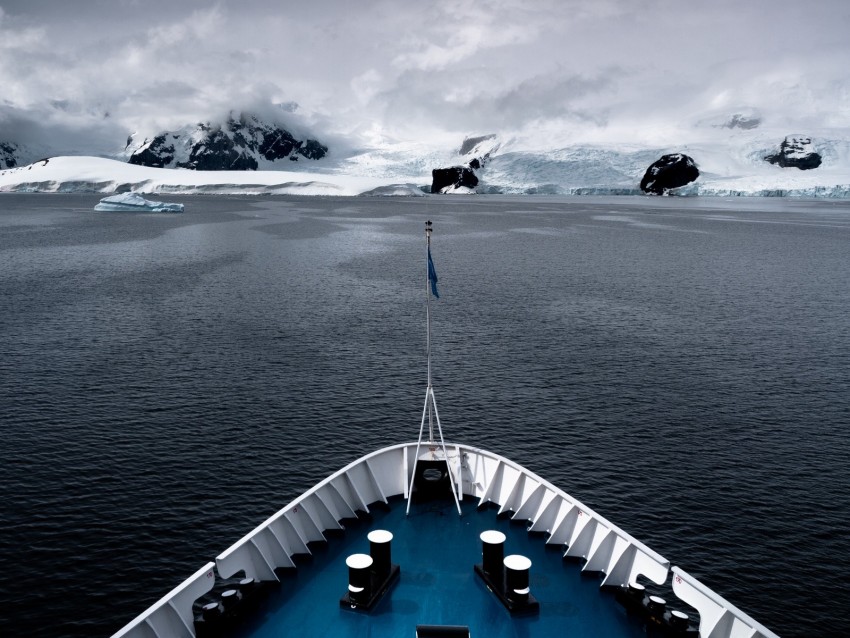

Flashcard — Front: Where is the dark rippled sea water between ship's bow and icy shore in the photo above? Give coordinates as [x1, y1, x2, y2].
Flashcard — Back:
[0, 194, 850, 637]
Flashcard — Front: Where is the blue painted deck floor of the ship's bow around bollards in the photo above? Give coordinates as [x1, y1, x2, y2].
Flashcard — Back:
[229, 500, 646, 638]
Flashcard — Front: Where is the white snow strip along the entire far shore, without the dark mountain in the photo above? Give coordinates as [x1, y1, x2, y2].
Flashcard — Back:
[0, 126, 850, 198]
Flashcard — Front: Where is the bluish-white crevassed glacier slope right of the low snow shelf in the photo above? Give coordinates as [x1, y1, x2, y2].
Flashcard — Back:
[328, 130, 850, 197]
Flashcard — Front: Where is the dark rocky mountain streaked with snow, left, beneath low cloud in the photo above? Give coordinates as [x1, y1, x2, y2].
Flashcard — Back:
[125, 113, 328, 171]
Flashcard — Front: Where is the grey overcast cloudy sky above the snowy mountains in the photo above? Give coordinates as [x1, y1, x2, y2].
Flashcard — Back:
[0, 0, 850, 152]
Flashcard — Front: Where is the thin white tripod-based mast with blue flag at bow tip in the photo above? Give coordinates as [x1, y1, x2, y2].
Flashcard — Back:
[405, 220, 461, 514]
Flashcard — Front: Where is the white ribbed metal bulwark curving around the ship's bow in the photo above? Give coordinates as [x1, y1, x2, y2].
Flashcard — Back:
[107, 442, 777, 638]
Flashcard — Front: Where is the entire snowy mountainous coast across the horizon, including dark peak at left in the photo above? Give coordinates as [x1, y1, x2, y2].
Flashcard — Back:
[0, 109, 850, 197]
